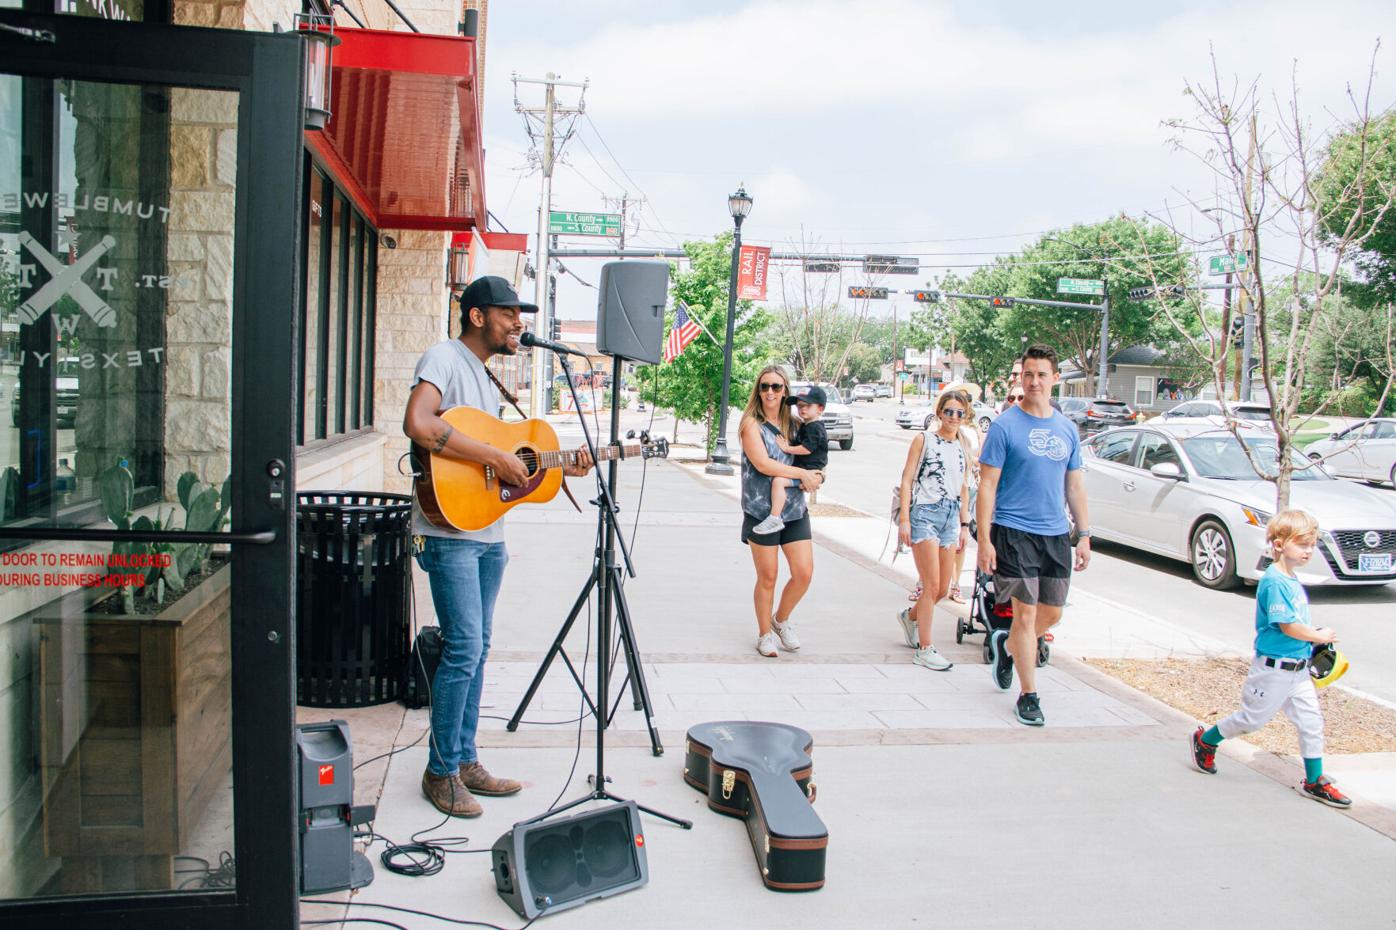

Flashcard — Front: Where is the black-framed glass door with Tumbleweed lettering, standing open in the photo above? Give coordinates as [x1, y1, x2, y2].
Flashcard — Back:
[0, 14, 300, 926]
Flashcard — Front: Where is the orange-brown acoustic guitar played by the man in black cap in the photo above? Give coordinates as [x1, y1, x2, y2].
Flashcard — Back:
[412, 406, 669, 529]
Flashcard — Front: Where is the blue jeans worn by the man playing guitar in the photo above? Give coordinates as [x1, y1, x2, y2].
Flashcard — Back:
[417, 536, 510, 775]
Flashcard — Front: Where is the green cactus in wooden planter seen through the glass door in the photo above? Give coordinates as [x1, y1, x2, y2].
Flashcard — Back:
[101, 461, 233, 613]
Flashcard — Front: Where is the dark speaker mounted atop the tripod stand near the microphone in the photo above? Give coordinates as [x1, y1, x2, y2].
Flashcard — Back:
[596, 261, 669, 364]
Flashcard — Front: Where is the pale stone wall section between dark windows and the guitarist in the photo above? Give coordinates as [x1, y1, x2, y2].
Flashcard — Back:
[373, 230, 456, 493]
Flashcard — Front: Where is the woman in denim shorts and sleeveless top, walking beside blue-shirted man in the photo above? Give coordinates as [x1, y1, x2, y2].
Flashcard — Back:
[899, 391, 972, 672]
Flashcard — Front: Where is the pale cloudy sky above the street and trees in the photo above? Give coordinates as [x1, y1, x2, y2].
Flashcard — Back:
[484, 0, 1396, 318]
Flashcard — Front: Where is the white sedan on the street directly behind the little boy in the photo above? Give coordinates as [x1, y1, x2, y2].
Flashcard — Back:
[1083, 420, 1396, 588]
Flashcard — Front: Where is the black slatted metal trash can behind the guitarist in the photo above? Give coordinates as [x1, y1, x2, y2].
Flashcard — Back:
[296, 492, 412, 707]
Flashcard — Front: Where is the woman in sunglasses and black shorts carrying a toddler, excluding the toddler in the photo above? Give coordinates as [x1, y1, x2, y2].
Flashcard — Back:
[740, 364, 822, 658]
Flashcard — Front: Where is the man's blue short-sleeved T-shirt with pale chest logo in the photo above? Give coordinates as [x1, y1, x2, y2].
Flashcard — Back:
[979, 406, 1081, 536]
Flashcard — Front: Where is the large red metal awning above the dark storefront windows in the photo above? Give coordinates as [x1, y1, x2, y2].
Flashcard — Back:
[306, 28, 484, 230]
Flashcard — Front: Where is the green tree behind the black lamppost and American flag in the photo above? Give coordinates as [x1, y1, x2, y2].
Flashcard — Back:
[646, 233, 772, 451]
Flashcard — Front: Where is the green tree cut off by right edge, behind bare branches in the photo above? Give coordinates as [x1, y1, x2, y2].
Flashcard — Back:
[1315, 113, 1396, 302]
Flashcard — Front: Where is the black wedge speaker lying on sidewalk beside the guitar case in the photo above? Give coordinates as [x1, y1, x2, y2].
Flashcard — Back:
[491, 802, 649, 920]
